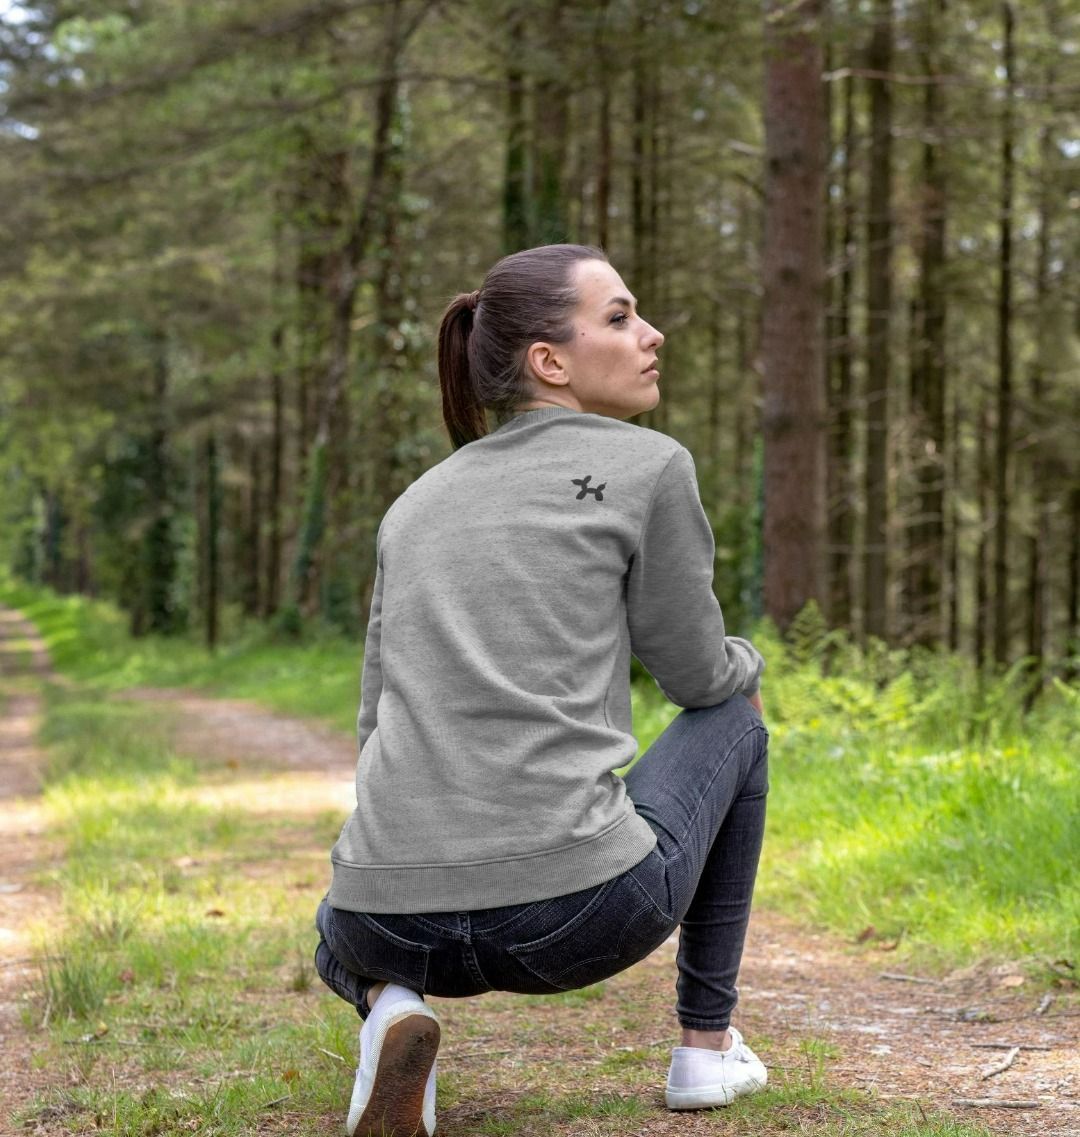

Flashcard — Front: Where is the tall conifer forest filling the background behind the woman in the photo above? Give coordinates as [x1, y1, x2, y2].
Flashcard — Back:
[0, 0, 1080, 687]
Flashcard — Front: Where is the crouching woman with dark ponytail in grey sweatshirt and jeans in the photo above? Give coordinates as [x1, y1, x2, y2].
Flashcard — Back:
[316, 244, 769, 1137]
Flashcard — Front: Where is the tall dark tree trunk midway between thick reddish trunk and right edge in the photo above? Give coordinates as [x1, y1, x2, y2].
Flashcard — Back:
[907, 0, 946, 646]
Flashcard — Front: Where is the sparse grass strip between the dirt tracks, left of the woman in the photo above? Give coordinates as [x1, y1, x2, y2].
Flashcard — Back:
[17, 688, 359, 1137]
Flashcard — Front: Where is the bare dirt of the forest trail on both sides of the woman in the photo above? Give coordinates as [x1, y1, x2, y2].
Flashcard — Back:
[0, 614, 1080, 1137]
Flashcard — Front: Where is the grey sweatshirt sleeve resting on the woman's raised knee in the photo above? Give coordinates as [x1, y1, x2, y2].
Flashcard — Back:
[626, 446, 765, 707]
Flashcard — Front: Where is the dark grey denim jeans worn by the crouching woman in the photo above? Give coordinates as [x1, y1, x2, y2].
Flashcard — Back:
[315, 695, 769, 1030]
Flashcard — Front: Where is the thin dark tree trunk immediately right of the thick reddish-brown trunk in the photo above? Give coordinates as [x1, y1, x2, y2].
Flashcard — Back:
[828, 68, 855, 628]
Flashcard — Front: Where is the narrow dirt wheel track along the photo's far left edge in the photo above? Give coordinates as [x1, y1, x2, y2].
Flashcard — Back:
[0, 607, 59, 1105]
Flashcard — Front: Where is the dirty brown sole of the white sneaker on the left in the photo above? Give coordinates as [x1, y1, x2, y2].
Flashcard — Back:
[352, 1014, 442, 1137]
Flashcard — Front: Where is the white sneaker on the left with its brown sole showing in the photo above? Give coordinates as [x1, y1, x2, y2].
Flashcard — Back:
[346, 984, 441, 1137]
